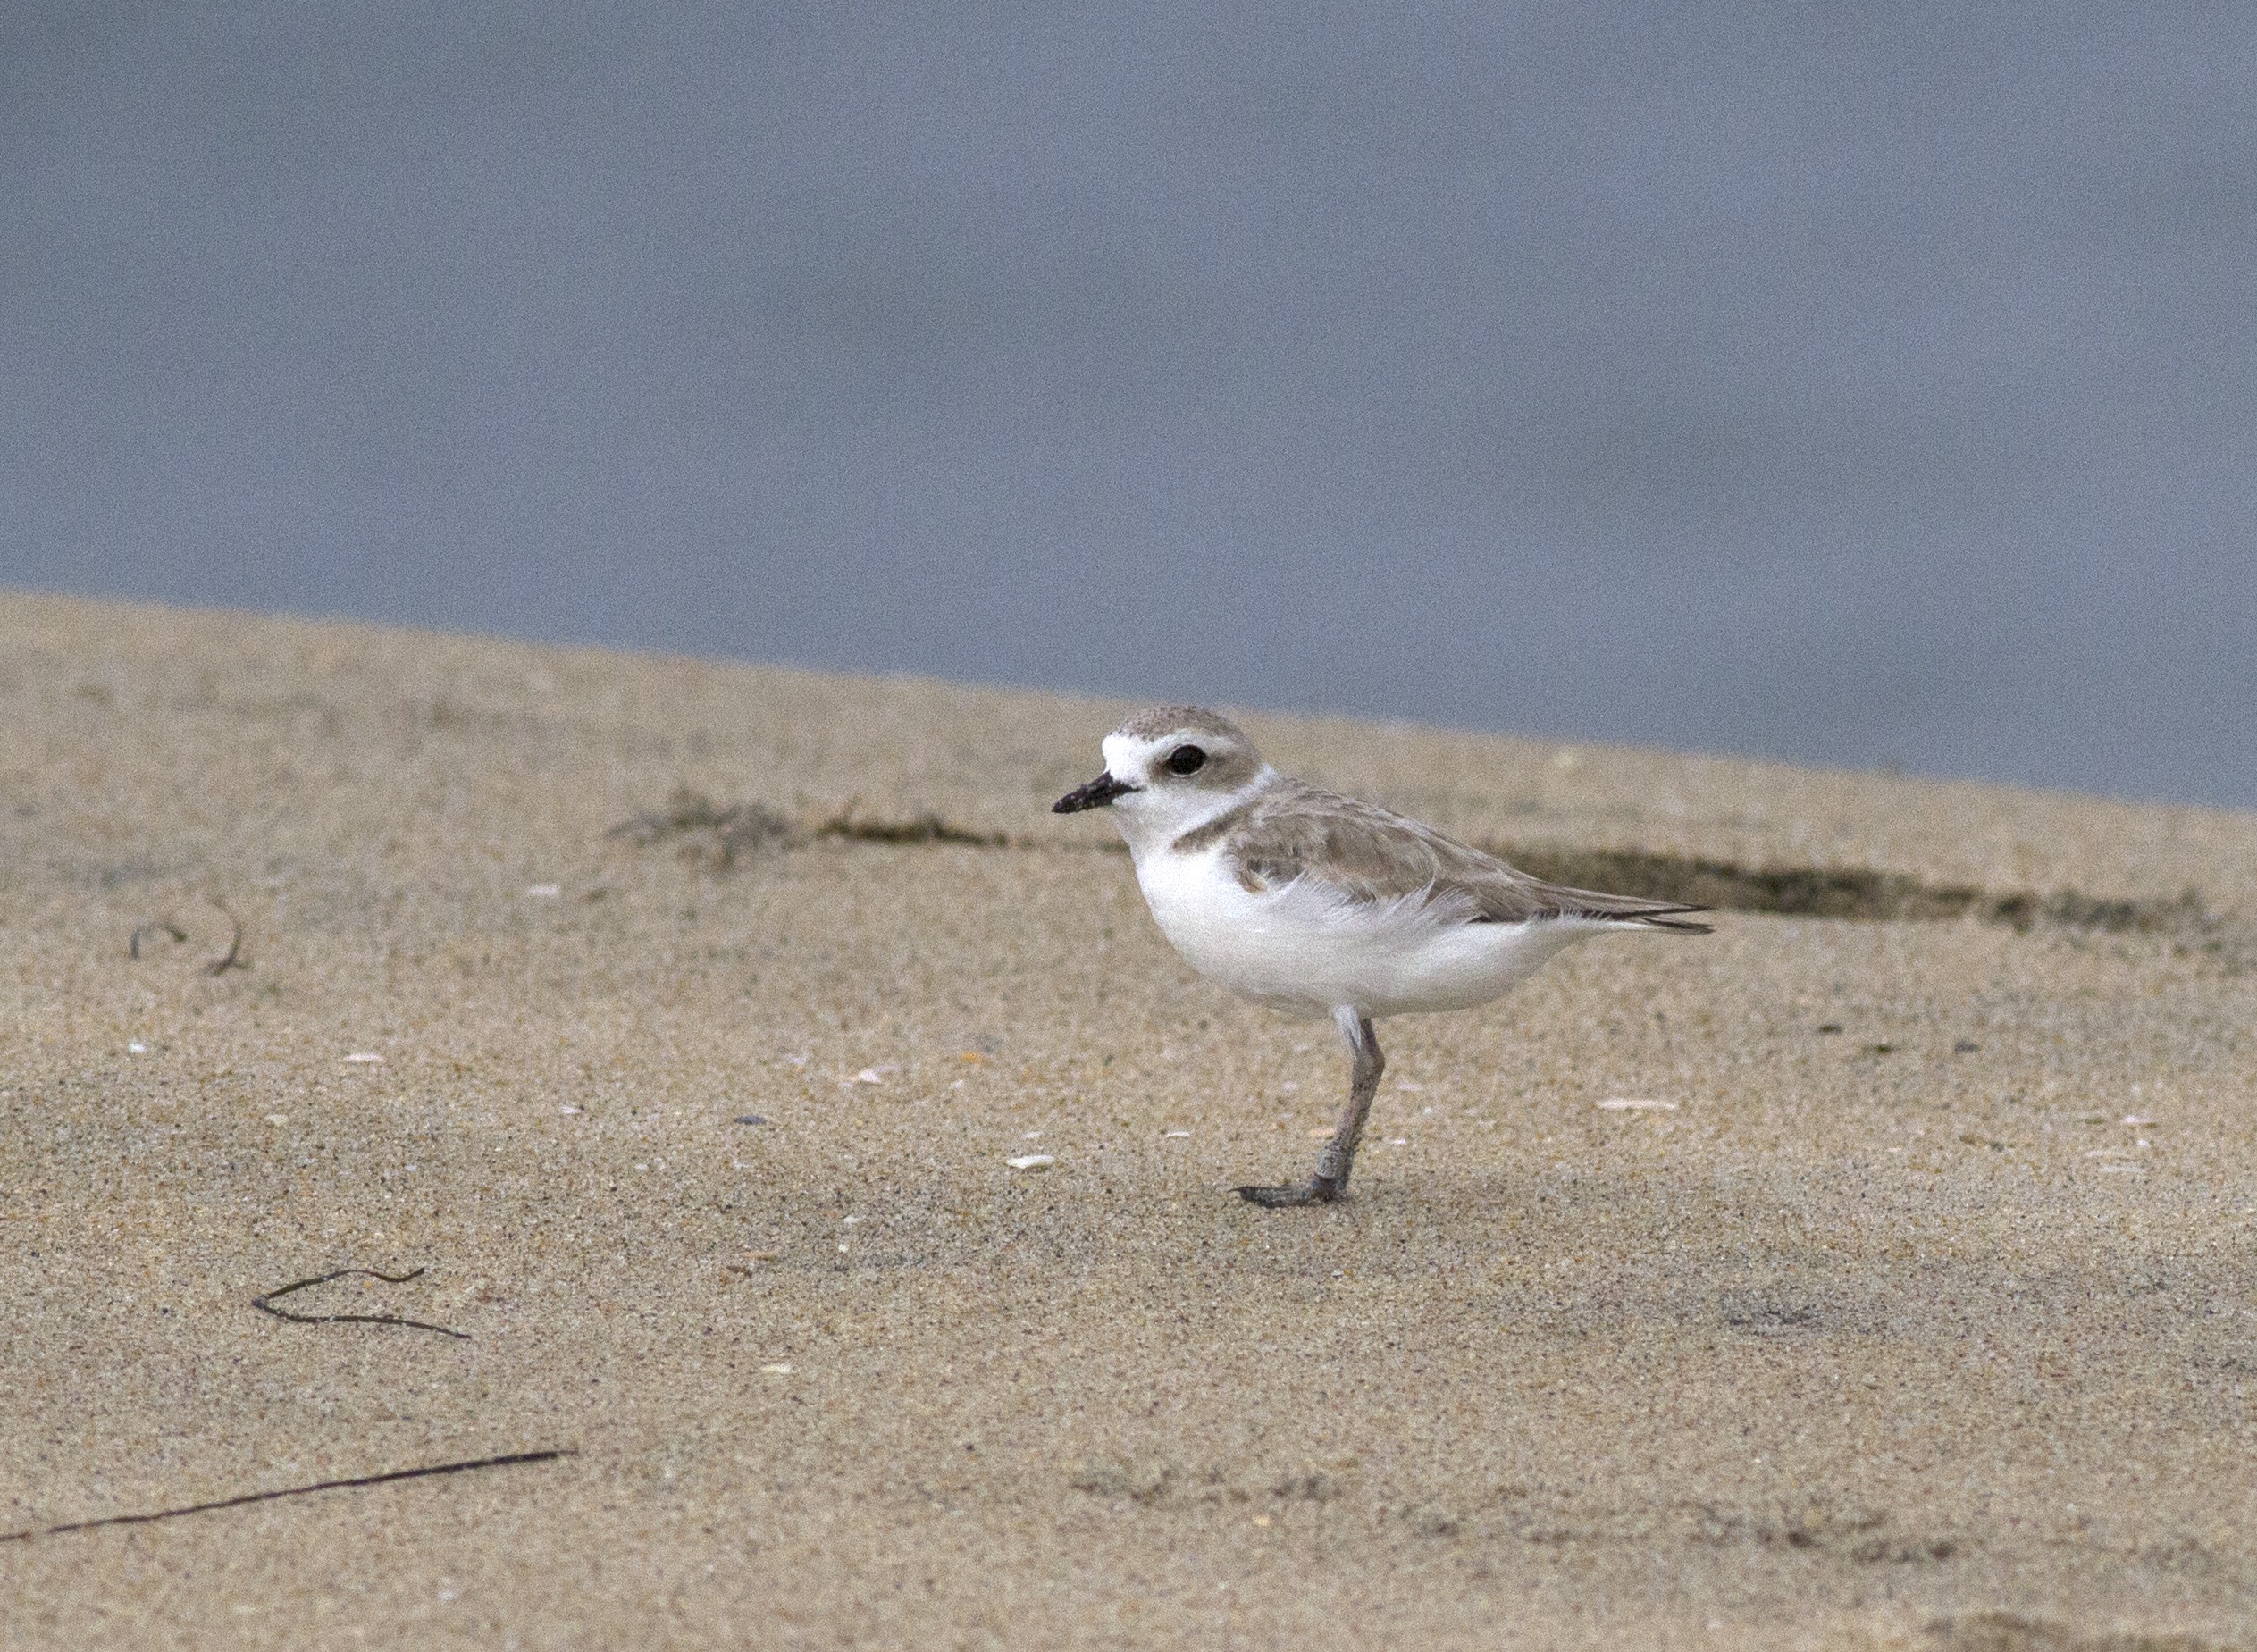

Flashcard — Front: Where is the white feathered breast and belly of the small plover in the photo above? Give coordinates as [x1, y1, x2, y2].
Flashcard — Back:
[1136, 849, 1600, 1016]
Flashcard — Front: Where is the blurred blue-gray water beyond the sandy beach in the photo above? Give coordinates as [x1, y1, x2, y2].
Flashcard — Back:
[0, 0, 2257, 803]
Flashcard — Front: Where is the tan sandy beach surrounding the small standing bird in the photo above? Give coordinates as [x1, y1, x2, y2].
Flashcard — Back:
[0, 596, 2257, 1652]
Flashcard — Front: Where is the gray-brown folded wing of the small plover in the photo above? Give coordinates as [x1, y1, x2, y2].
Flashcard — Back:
[1179, 781, 1708, 932]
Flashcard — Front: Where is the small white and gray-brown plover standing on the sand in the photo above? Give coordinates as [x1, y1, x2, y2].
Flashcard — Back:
[1052, 707, 1708, 1207]
